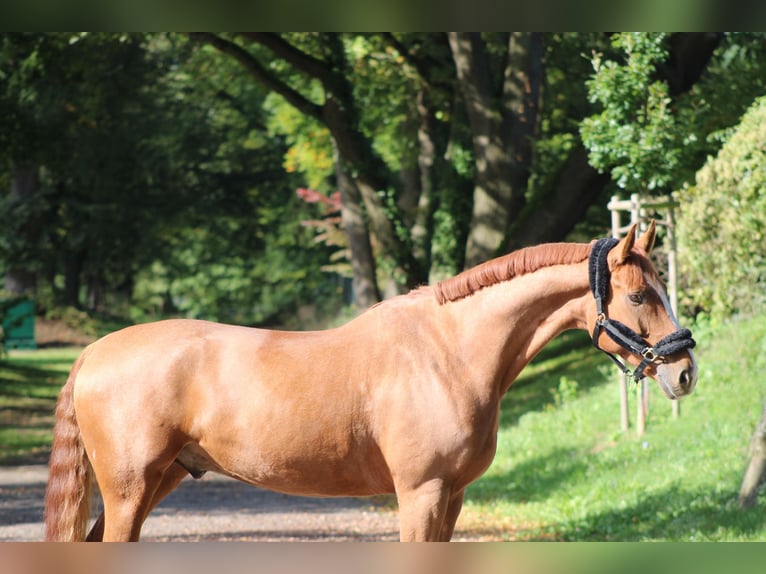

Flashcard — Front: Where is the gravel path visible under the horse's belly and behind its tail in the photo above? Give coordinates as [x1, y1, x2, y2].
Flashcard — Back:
[0, 465, 398, 542]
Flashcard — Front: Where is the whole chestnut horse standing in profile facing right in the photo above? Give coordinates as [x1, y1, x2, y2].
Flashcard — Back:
[45, 225, 697, 541]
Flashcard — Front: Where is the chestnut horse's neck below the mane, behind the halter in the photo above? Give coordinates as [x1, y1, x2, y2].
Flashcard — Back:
[447, 263, 593, 394]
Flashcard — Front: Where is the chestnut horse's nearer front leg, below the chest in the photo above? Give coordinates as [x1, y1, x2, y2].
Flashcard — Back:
[396, 479, 450, 542]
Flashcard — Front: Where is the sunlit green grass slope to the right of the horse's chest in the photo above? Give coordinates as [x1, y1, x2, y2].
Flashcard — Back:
[458, 316, 766, 541]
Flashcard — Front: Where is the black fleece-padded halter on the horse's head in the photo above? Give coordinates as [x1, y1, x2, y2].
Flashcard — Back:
[588, 238, 697, 382]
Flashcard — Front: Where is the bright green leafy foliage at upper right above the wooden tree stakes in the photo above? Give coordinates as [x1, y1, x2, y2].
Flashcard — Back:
[581, 33, 766, 204]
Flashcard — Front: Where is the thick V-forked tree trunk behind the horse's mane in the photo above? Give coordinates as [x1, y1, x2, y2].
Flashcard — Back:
[449, 32, 543, 267]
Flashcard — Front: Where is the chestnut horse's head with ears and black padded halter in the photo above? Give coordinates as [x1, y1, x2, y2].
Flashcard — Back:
[590, 221, 697, 399]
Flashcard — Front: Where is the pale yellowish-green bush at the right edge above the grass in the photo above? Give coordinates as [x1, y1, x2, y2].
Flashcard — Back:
[678, 98, 766, 319]
